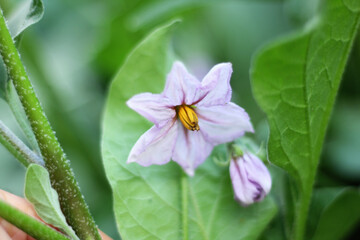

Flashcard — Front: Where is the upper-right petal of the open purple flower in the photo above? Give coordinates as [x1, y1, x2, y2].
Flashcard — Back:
[198, 63, 232, 106]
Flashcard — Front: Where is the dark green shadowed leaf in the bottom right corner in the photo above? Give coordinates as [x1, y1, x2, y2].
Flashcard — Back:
[307, 188, 360, 240]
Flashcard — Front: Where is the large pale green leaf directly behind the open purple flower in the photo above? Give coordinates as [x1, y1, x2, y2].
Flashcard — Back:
[102, 20, 276, 240]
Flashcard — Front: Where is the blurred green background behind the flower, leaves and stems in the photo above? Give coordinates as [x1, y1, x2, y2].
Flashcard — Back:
[0, 0, 360, 239]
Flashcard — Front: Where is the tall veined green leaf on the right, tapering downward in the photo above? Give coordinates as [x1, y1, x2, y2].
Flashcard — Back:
[251, 0, 360, 239]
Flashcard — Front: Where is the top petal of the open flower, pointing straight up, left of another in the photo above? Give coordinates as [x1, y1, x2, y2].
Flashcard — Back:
[162, 62, 201, 106]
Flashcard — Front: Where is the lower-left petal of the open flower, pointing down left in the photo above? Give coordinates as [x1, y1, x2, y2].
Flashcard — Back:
[127, 120, 178, 167]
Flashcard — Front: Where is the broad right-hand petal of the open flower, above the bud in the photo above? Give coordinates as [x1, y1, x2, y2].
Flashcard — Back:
[195, 102, 254, 145]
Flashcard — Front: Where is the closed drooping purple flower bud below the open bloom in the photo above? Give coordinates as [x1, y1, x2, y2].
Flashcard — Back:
[230, 152, 271, 206]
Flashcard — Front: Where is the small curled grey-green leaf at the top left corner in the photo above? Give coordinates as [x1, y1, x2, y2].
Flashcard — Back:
[7, 0, 44, 39]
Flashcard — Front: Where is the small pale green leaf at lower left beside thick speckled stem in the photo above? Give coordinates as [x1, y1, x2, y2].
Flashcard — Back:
[25, 164, 79, 240]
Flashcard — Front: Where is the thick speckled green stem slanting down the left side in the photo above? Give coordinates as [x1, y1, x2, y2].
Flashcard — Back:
[0, 9, 101, 240]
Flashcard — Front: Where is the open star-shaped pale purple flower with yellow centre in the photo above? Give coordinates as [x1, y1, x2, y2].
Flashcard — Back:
[127, 62, 253, 176]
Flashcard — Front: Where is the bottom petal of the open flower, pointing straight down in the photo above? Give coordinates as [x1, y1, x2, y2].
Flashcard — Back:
[172, 121, 213, 176]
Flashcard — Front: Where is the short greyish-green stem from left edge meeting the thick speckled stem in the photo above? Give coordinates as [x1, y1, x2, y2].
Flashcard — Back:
[0, 121, 44, 167]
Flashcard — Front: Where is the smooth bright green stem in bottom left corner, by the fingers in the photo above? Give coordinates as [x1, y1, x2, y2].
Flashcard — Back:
[0, 200, 69, 240]
